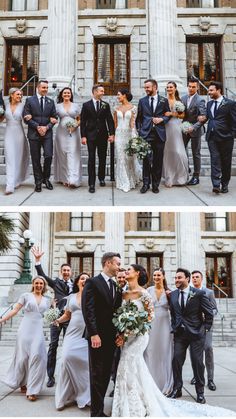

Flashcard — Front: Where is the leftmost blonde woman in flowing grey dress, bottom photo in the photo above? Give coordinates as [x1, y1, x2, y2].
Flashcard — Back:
[0, 276, 51, 401]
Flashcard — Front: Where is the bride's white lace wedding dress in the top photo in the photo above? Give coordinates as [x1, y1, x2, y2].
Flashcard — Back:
[115, 106, 142, 192]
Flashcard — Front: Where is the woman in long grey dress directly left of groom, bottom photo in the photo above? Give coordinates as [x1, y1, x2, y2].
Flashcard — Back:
[55, 272, 90, 410]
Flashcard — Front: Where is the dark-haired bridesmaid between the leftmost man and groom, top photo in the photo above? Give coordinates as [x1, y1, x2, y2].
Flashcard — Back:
[54, 87, 82, 188]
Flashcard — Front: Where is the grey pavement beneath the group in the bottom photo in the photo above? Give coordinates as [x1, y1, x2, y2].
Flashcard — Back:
[0, 347, 236, 417]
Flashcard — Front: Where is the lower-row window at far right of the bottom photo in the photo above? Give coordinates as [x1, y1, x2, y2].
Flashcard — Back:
[206, 254, 232, 298]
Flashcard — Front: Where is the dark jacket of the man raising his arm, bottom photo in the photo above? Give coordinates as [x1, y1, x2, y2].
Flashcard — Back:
[35, 265, 70, 310]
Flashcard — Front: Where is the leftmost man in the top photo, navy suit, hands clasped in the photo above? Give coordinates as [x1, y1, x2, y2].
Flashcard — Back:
[24, 80, 57, 192]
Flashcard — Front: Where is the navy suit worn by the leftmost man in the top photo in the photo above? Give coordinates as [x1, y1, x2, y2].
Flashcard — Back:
[24, 95, 57, 184]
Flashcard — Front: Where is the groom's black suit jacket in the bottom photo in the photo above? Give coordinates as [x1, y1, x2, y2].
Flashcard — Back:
[82, 274, 122, 342]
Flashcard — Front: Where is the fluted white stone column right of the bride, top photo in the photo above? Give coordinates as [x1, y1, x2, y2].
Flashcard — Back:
[146, 0, 182, 93]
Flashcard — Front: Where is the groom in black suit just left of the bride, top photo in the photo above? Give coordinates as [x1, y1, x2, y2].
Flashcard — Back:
[80, 85, 115, 193]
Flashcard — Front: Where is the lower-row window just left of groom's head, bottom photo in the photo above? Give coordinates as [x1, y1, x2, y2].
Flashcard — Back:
[67, 253, 94, 278]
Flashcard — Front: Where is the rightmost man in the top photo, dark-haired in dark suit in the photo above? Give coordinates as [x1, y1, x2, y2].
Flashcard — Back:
[199, 81, 236, 194]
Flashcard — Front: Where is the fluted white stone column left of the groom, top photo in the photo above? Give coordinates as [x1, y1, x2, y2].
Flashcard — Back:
[48, 0, 78, 89]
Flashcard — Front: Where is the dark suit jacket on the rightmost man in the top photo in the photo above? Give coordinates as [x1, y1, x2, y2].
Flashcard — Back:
[206, 97, 236, 141]
